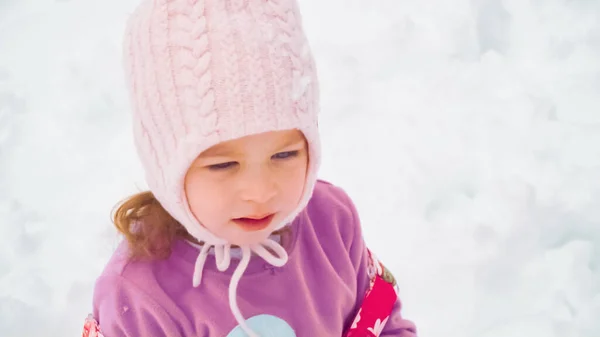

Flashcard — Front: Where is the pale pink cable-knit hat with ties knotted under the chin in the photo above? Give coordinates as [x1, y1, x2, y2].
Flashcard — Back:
[124, 0, 320, 327]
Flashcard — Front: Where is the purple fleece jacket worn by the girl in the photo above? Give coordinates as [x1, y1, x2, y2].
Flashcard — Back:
[93, 181, 416, 337]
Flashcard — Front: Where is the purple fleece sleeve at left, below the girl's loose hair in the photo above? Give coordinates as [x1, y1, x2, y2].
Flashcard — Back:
[93, 274, 182, 337]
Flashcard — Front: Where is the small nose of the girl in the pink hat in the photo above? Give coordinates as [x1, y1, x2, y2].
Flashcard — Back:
[240, 168, 277, 204]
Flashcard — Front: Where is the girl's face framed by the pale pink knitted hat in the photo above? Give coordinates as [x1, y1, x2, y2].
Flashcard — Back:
[185, 130, 308, 245]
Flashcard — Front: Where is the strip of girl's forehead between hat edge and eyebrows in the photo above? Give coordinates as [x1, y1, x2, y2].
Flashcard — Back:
[200, 129, 306, 157]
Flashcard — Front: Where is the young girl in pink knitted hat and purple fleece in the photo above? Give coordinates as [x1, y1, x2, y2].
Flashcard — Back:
[84, 0, 416, 337]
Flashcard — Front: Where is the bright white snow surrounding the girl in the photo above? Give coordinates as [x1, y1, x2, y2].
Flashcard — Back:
[0, 0, 600, 337]
